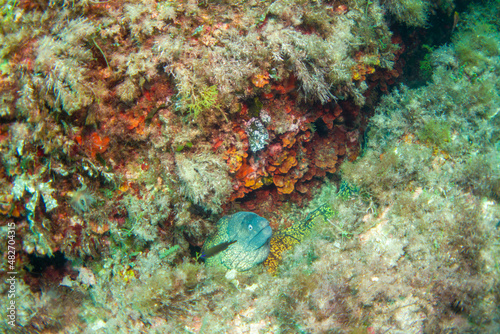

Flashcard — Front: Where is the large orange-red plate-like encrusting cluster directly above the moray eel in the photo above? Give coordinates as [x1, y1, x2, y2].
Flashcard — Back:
[223, 91, 359, 202]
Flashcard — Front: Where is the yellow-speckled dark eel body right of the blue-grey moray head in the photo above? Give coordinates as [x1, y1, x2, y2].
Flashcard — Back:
[264, 204, 334, 275]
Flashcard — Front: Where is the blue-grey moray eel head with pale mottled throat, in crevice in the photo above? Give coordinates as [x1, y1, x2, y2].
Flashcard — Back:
[201, 211, 272, 271]
